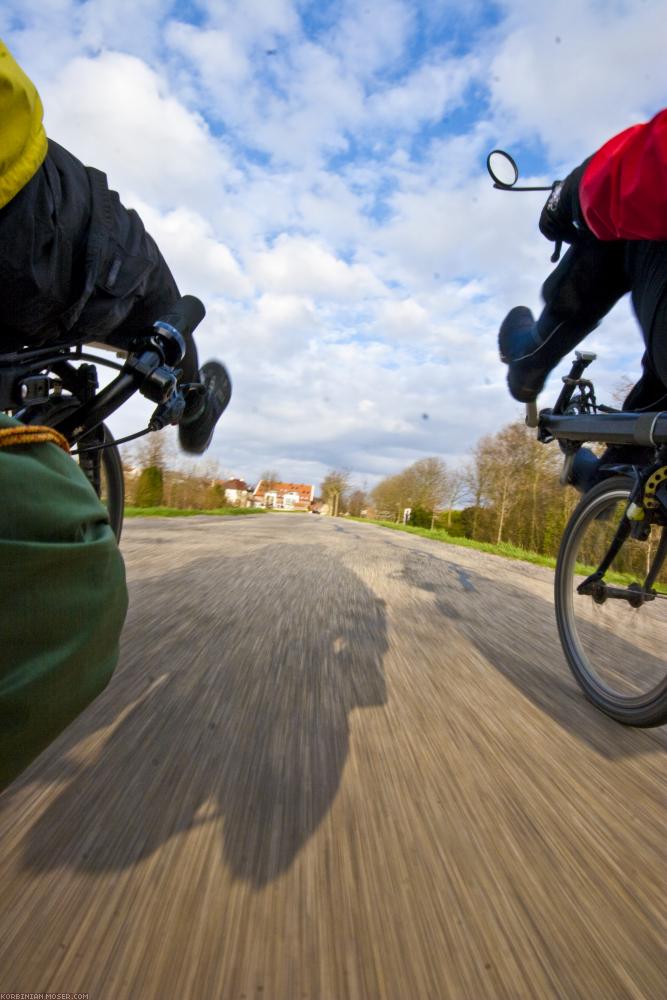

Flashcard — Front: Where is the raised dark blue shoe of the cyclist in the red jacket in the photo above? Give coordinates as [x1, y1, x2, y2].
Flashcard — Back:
[498, 306, 552, 403]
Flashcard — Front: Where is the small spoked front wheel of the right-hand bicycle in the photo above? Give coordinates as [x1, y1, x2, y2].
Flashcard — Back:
[555, 476, 667, 726]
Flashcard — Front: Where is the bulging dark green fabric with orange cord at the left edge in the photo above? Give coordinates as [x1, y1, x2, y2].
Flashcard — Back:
[0, 414, 127, 791]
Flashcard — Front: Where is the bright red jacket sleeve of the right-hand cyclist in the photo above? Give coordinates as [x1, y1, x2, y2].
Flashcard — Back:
[579, 110, 667, 240]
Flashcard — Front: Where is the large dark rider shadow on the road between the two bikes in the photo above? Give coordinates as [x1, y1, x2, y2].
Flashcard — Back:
[14, 543, 388, 888]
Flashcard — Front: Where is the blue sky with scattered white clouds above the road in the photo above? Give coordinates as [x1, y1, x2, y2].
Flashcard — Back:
[0, 0, 667, 487]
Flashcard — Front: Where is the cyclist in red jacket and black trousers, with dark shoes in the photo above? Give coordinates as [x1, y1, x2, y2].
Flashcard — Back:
[498, 110, 667, 486]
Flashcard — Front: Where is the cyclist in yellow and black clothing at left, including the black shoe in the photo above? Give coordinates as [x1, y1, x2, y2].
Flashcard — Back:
[0, 42, 231, 454]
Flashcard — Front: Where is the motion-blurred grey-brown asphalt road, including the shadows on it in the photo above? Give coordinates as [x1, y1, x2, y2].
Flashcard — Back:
[0, 514, 667, 1000]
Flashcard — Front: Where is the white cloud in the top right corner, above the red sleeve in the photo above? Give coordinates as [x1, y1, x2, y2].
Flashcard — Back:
[490, 0, 665, 158]
